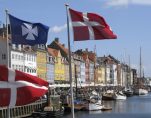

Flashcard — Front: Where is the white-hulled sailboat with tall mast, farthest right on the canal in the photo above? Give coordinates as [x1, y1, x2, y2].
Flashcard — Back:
[134, 47, 148, 95]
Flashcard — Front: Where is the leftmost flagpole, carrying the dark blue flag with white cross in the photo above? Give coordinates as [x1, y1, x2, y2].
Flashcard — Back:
[5, 9, 10, 118]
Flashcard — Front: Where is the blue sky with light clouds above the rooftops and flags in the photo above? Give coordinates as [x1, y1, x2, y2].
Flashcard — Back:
[0, 0, 151, 77]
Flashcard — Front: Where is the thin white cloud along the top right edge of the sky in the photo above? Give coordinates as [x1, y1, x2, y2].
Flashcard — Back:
[106, 0, 151, 6]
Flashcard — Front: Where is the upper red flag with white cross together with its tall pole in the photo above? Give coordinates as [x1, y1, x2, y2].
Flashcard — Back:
[65, 4, 117, 118]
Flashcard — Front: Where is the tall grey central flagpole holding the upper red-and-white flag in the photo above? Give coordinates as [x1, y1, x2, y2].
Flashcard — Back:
[65, 4, 75, 118]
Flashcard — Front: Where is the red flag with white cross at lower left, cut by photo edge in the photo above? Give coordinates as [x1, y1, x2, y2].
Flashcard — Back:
[0, 65, 48, 107]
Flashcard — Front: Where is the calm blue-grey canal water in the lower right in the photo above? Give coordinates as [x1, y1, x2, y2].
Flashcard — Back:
[62, 93, 151, 118]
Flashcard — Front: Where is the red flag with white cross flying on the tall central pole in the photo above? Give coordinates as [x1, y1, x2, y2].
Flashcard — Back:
[69, 8, 117, 41]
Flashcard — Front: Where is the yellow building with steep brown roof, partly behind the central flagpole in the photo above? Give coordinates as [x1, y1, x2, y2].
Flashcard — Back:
[48, 38, 75, 83]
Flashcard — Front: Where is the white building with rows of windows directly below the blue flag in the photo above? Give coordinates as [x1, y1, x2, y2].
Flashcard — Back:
[10, 44, 37, 76]
